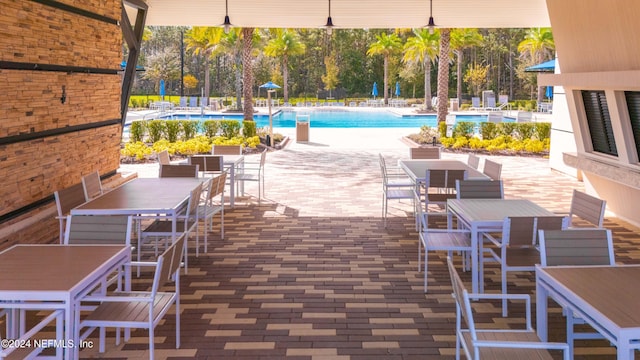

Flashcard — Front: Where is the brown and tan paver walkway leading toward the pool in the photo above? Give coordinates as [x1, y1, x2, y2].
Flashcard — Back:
[81, 128, 640, 360]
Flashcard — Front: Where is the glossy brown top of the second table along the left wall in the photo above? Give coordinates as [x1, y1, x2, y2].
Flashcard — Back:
[71, 177, 204, 215]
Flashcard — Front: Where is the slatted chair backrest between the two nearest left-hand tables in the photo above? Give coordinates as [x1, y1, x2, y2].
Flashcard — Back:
[64, 215, 132, 246]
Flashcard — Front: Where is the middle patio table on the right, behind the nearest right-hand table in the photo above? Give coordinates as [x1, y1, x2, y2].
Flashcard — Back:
[447, 199, 555, 293]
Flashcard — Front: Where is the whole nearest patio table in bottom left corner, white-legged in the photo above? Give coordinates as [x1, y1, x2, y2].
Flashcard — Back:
[0, 244, 131, 359]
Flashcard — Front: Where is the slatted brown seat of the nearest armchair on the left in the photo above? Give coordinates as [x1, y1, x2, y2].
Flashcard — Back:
[83, 292, 176, 328]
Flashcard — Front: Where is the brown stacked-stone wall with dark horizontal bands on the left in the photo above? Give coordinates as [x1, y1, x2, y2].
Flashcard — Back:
[0, 0, 122, 247]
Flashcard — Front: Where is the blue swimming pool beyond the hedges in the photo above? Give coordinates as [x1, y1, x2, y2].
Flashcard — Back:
[158, 109, 509, 128]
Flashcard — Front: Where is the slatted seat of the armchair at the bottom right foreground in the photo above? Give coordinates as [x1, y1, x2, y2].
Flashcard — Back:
[463, 330, 553, 360]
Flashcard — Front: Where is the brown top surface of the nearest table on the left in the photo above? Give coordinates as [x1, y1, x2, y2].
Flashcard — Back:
[0, 244, 131, 292]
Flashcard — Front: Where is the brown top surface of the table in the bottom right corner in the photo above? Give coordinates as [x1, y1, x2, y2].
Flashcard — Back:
[536, 266, 640, 328]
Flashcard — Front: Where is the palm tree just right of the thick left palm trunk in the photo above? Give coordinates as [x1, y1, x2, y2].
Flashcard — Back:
[264, 29, 306, 103]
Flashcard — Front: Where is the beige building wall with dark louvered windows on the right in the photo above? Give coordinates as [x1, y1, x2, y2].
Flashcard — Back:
[539, 0, 640, 225]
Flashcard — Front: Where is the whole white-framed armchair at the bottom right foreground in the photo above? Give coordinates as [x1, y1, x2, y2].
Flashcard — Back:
[447, 257, 571, 360]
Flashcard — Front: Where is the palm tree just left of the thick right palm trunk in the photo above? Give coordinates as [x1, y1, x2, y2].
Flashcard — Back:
[402, 28, 440, 110]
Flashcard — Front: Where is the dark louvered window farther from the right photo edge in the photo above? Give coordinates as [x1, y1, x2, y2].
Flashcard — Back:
[582, 90, 618, 156]
